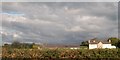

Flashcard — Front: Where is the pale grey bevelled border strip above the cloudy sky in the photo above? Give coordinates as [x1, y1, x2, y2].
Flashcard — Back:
[2, 0, 119, 2]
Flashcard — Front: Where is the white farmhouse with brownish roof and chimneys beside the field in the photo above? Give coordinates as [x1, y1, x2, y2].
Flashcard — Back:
[88, 39, 116, 49]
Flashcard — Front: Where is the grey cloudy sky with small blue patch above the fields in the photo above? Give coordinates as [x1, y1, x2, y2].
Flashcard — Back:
[0, 2, 118, 44]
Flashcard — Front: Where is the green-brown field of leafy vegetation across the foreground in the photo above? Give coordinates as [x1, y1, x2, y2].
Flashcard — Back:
[2, 48, 120, 60]
